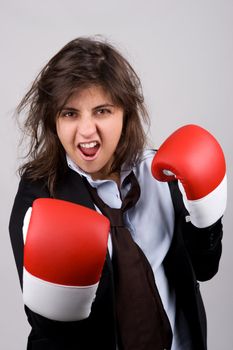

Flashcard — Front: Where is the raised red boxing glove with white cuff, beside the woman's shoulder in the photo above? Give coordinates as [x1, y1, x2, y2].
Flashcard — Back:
[151, 125, 227, 228]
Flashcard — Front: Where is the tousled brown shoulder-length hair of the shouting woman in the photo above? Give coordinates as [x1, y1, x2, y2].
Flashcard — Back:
[17, 37, 149, 193]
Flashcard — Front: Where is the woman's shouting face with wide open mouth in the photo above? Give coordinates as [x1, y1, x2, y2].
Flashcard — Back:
[56, 86, 124, 179]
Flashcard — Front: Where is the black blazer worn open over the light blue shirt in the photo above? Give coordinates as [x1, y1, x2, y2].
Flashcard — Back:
[9, 169, 222, 350]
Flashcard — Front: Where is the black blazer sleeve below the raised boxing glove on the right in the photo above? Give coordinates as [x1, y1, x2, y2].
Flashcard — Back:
[169, 181, 223, 281]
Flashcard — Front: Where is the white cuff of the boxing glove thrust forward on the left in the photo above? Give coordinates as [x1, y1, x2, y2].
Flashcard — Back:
[23, 268, 99, 321]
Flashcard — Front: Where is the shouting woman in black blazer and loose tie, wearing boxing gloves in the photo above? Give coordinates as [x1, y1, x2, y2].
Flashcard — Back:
[10, 38, 224, 350]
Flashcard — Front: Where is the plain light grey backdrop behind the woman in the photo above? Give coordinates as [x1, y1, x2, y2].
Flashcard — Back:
[0, 0, 233, 350]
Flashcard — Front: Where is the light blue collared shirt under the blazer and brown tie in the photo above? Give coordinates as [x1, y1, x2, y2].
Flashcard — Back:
[67, 150, 191, 350]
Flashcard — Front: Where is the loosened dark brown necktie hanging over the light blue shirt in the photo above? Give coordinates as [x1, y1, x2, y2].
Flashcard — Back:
[83, 172, 172, 350]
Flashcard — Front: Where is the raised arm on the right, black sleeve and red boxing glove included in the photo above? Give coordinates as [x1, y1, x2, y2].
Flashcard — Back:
[152, 125, 227, 280]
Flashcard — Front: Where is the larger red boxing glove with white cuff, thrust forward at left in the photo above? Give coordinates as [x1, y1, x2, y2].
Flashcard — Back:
[23, 198, 110, 321]
